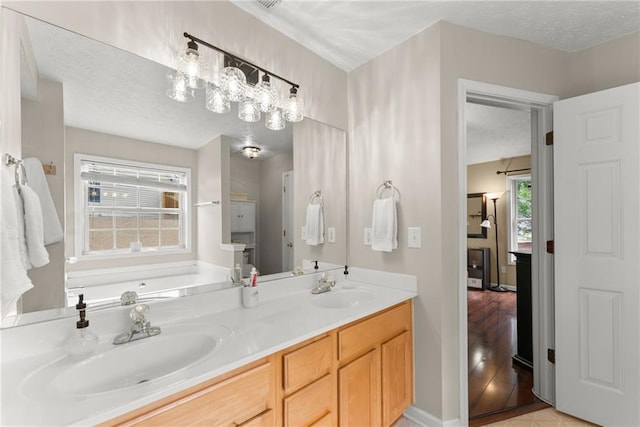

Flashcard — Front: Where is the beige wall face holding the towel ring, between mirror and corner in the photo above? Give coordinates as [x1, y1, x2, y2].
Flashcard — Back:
[348, 21, 442, 417]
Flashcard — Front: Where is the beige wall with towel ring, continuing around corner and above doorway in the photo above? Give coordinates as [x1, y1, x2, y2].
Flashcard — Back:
[349, 22, 640, 420]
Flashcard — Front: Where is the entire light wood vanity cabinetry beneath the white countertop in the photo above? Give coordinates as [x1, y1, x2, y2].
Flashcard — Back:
[104, 301, 413, 427]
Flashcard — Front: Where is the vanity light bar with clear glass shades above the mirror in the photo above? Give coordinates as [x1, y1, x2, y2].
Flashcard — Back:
[167, 33, 304, 130]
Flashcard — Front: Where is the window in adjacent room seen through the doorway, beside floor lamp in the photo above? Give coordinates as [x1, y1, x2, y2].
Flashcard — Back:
[507, 175, 532, 264]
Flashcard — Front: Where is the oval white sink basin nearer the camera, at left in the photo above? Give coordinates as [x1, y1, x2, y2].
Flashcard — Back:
[50, 334, 219, 395]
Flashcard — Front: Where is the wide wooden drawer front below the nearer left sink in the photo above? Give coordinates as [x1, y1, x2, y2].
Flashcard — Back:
[125, 363, 275, 426]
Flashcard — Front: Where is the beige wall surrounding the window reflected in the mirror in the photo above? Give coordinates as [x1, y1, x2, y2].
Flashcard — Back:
[61, 126, 198, 272]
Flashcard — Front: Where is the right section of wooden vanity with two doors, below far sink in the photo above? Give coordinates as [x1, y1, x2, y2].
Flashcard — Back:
[338, 301, 413, 426]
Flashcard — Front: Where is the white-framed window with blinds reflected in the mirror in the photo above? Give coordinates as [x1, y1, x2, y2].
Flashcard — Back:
[75, 154, 190, 256]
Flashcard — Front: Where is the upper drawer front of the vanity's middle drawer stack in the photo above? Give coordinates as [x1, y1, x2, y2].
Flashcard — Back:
[282, 336, 332, 394]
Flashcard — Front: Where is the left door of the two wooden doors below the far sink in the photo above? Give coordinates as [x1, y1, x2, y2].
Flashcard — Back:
[338, 349, 380, 427]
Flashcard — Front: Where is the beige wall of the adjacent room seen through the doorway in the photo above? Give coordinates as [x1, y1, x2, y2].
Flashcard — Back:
[467, 156, 531, 287]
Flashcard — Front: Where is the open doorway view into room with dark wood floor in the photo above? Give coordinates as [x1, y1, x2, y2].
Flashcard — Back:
[465, 97, 539, 424]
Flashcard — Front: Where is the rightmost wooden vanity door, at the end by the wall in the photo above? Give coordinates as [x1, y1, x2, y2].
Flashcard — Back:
[382, 331, 413, 426]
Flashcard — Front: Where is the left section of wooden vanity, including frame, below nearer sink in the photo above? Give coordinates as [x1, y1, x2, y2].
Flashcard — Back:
[105, 356, 275, 426]
